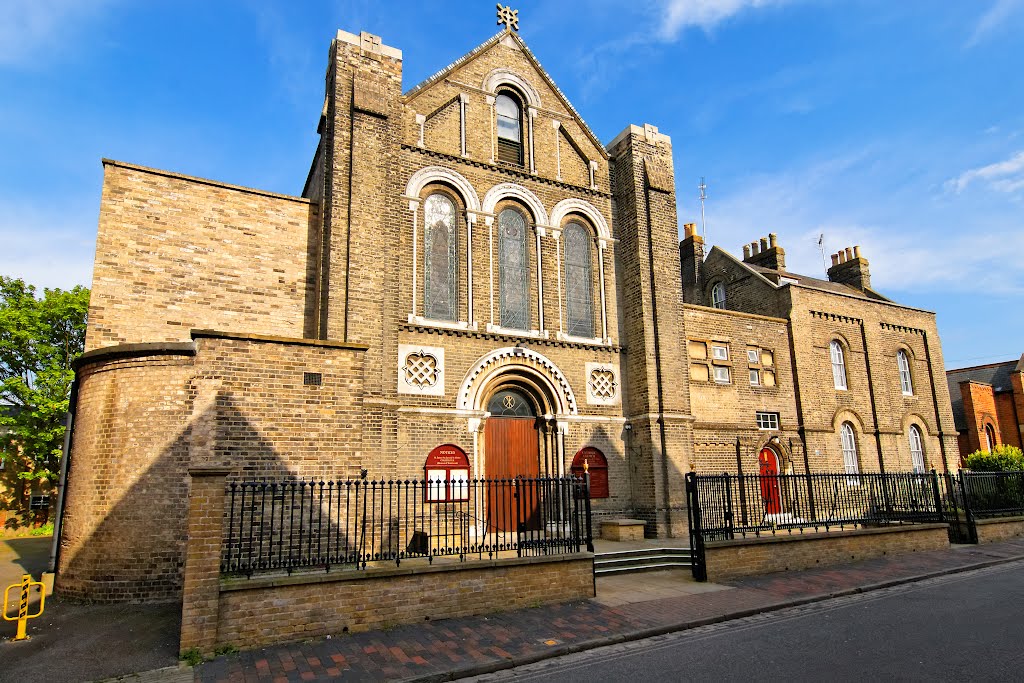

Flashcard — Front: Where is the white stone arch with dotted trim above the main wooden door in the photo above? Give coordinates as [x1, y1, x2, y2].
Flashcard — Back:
[458, 346, 579, 415]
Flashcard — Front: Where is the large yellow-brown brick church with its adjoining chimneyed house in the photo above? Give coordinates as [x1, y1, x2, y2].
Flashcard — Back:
[57, 18, 957, 600]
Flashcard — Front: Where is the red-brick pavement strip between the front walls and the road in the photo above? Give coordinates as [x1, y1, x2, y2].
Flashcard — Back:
[194, 540, 1024, 683]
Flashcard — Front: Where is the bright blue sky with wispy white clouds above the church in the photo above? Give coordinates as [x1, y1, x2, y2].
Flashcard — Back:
[0, 0, 1024, 368]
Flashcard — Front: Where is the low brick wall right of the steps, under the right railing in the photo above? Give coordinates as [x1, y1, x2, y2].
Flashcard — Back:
[705, 524, 949, 582]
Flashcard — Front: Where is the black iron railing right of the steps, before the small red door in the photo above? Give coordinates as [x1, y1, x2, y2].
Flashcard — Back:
[686, 471, 946, 581]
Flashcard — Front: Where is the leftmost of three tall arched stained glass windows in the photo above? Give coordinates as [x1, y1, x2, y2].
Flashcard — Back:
[423, 193, 458, 321]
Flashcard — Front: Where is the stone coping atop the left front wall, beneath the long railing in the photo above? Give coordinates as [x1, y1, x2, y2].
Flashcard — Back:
[220, 552, 594, 593]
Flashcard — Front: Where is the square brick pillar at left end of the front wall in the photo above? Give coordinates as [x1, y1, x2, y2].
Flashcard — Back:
[179, 466, 230, 654]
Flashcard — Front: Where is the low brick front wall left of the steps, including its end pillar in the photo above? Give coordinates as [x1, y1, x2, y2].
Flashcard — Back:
[180, 467, 594, 654]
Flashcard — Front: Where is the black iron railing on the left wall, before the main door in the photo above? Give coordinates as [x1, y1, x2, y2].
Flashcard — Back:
[221, 476, 594, 575]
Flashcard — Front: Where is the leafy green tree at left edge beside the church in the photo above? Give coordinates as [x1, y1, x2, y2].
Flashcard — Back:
[0, 275, 89, 481]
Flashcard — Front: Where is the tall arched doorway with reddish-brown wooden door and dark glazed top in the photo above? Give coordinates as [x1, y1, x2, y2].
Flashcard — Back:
[483, 386, 541, 531]
